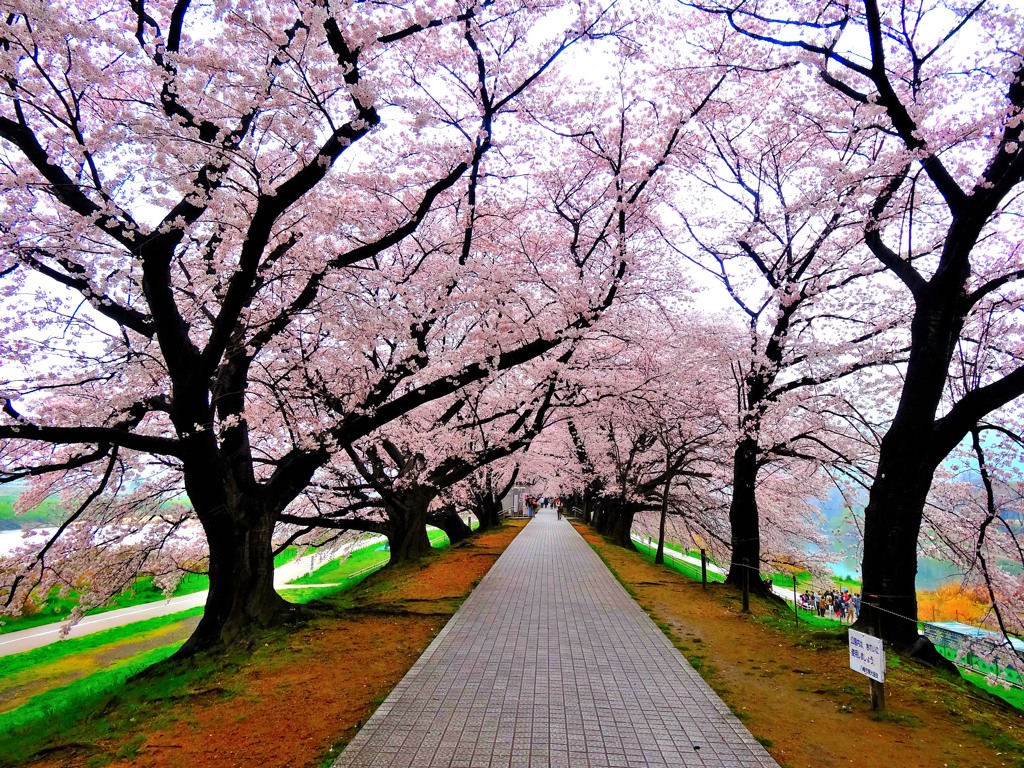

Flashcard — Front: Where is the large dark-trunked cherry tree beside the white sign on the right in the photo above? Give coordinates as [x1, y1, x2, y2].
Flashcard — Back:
[696, 0, 1024, 647]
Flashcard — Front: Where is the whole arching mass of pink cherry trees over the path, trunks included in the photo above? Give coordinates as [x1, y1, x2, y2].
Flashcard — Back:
[0, 0, 1024, 653]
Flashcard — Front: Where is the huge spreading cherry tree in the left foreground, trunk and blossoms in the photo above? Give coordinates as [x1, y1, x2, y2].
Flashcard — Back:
[0, 0, 624, 653]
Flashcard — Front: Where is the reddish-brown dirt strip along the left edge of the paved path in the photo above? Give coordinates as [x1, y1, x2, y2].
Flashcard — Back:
[22, 523, 522, 768]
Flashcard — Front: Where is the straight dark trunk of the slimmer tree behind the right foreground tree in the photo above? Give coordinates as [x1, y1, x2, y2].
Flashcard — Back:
[725, 437, 766, 591]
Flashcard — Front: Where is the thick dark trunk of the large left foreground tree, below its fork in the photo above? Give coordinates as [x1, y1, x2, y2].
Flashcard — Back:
[175, 503, 288, 658]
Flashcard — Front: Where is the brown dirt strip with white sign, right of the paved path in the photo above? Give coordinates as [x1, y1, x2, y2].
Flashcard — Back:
[581, 529, 1024, 768]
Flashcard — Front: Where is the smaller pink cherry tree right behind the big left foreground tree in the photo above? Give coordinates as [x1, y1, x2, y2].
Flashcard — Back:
[279, 346, 571, 563]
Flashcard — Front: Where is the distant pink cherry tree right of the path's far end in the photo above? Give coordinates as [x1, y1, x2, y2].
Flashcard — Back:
[562, 302, 732, 547]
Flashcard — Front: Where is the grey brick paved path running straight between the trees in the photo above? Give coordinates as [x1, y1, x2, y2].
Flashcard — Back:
[335, 512, 777, 768]
